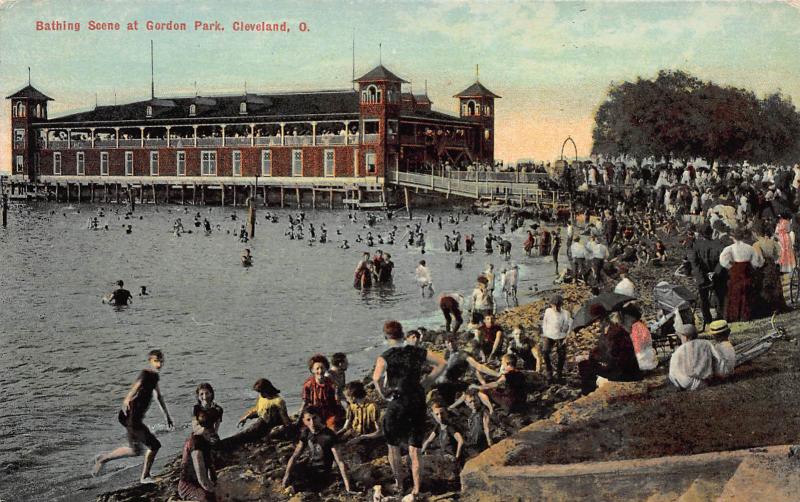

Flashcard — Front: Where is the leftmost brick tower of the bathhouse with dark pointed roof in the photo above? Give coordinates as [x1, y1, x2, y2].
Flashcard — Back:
[6, 82, 53, 181]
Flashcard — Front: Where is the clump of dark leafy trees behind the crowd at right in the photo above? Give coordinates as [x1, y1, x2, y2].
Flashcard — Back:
[592, 70, 800, 165]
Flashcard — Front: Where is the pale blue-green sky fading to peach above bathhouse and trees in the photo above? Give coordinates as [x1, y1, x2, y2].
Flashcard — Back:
[0, 0, 800, 171]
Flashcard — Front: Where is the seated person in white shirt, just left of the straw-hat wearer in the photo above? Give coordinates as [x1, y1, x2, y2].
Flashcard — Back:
[669, 324, 719, 390]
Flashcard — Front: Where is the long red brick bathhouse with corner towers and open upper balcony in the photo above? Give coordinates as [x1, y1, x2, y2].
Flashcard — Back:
[6, 65, 499, 183]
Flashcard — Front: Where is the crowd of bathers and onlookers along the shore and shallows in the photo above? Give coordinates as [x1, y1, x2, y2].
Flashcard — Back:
[86, 156, 800, 501]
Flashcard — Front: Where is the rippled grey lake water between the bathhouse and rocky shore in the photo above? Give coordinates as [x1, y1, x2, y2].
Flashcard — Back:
[0, 204, 563, 501]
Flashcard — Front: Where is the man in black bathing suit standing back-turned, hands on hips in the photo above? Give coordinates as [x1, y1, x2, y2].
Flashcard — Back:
[372, 321, 445, 496]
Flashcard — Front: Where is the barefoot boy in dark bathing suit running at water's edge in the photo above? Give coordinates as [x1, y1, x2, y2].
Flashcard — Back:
[93, 350, 173, 483]
